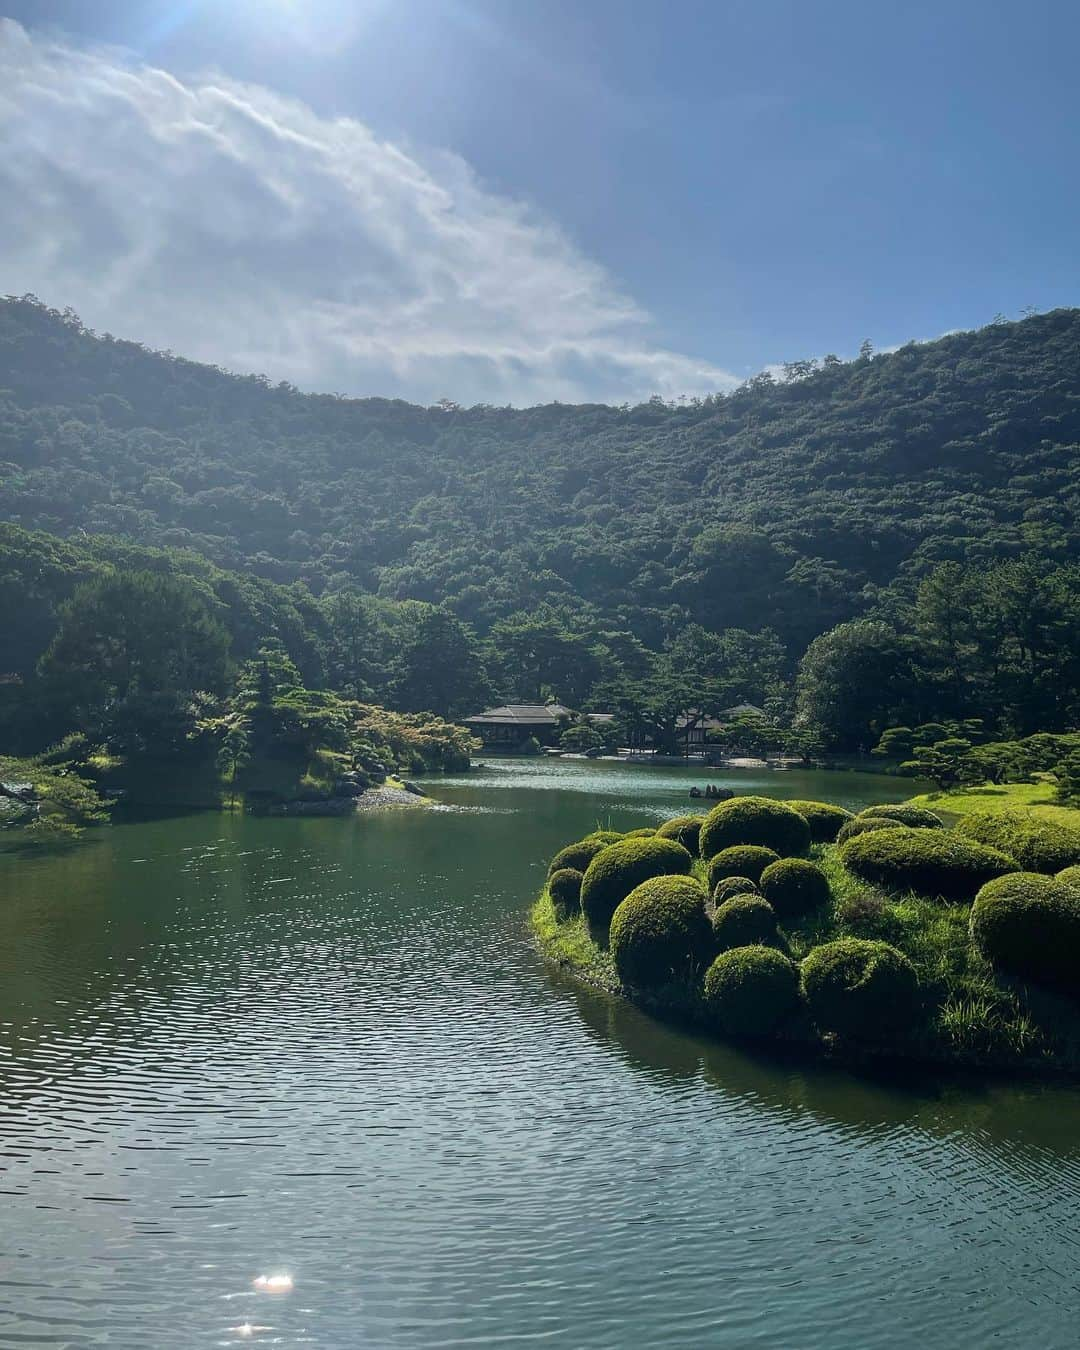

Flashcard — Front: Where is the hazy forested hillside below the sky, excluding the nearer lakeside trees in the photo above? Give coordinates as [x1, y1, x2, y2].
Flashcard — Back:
[0, 298, 1080, 655]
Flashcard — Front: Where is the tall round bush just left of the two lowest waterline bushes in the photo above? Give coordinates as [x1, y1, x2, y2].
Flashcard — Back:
[610, 876, 716, 988]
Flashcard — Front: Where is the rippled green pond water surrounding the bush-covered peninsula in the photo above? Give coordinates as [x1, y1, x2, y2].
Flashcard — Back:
[0, 761, 1080, 1350]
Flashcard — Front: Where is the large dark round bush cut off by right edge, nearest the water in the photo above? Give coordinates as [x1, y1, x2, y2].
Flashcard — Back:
[971, 872, 1080, 987]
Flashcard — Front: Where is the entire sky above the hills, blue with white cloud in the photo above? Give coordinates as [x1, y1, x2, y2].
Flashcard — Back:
[0, 0, 1080, 402]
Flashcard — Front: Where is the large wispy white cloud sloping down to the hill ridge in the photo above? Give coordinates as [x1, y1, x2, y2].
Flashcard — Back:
[0, 20, 737, 404]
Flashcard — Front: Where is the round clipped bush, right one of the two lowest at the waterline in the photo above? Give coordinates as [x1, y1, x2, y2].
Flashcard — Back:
[802, 937, 918, 1041]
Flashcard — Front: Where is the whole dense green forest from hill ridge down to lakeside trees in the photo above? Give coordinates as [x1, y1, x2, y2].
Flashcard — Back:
[0, 297, 1080, 783]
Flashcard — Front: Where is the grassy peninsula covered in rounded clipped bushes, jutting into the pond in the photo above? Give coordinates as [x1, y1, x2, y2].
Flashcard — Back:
[532, 797, 1080, 1075]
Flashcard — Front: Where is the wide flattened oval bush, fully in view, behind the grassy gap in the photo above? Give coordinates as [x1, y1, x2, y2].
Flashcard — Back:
[840, 826, 1017, 900]
